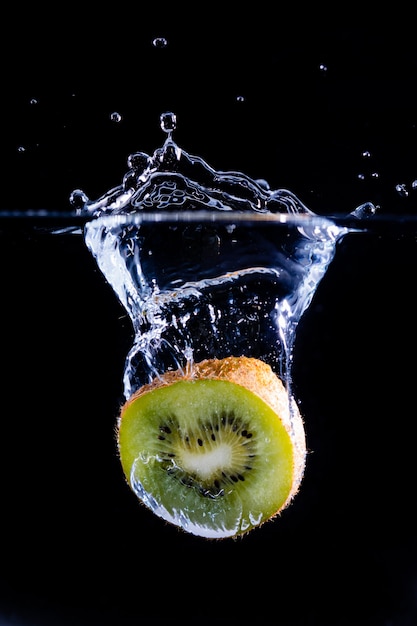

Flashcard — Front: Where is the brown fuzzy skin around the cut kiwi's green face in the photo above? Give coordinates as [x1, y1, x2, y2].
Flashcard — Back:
[116, 356, 307, 536]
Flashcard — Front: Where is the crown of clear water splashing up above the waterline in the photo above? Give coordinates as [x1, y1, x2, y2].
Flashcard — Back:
[70, 113, 324, 217]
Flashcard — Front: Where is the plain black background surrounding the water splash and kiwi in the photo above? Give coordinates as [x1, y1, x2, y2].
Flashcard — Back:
[0, 3, 417, 626]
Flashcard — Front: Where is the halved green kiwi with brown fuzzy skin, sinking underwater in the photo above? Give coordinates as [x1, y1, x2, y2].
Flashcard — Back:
[117, 357, 306, 538]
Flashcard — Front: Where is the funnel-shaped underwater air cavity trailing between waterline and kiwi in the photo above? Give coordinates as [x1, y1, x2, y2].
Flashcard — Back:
[85, 215, 347, 398]
